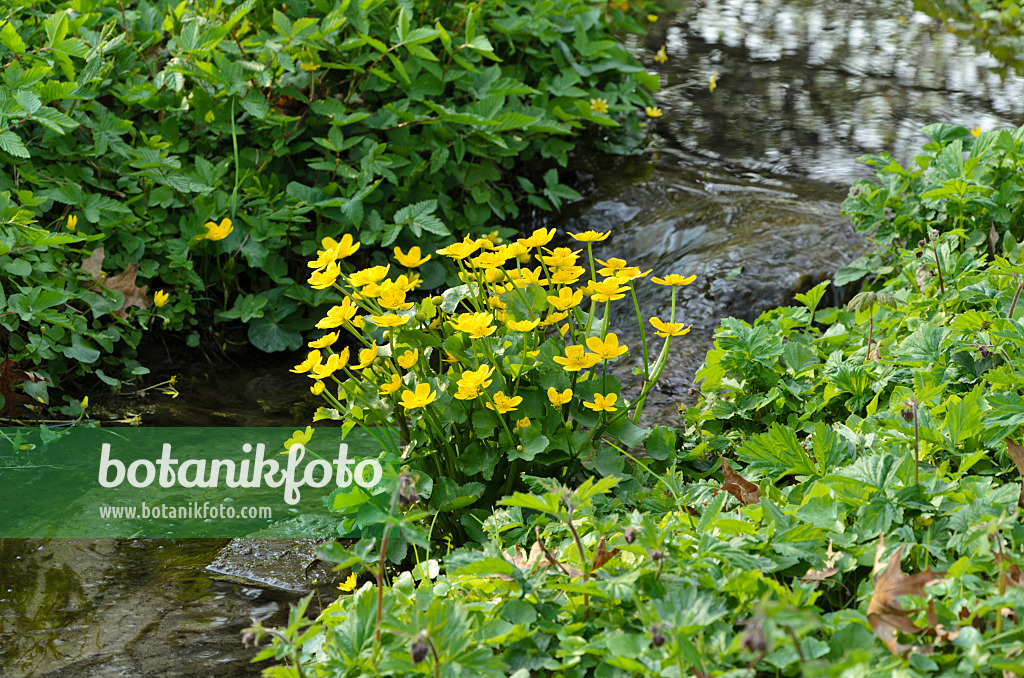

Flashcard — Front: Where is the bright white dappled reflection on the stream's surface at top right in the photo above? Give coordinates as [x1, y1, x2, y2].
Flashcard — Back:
[645, 0, 1024, 184]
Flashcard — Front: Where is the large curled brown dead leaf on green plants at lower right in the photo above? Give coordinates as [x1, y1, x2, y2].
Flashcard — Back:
[867, 540, 945, 655]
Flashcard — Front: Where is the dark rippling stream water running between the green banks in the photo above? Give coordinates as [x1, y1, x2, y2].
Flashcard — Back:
[0, 0, 1024, 678]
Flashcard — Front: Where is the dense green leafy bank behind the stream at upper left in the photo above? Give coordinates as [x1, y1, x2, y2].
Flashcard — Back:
[0, 0, 657, 398]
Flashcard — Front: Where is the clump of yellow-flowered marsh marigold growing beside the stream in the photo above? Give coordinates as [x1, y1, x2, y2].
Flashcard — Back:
[293, 228, 694, 538]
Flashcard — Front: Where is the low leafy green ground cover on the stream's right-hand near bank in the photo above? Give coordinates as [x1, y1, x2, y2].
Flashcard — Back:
[248, 126, 1024, 678]
